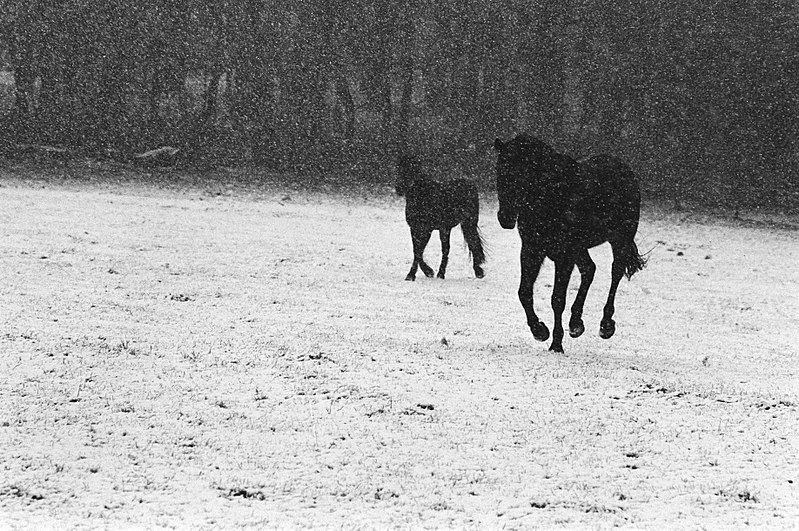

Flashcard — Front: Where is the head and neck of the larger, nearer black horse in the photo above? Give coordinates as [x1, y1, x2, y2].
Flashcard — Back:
[494, 133, 552, 229]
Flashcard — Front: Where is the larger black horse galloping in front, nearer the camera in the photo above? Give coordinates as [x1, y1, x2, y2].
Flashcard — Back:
[494, 134, 646, 352]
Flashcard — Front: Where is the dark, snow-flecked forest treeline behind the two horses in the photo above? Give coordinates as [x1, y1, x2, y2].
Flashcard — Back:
[0, 0, 799, 206]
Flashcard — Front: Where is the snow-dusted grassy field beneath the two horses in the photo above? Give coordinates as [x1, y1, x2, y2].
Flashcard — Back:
[0, 172, 799, 529]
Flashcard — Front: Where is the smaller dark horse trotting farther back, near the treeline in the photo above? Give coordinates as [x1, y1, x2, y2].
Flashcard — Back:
[396, 155, 485, 280]
